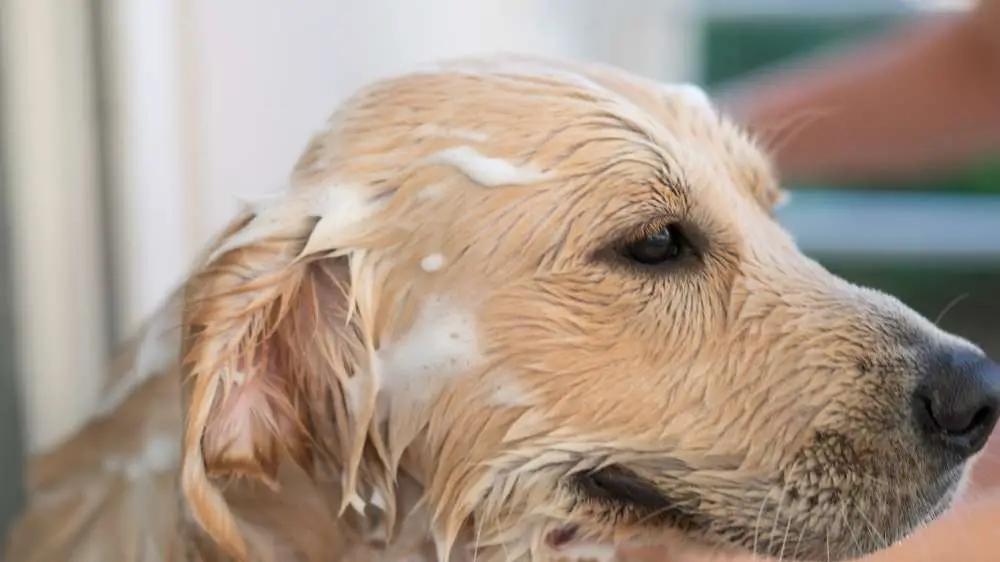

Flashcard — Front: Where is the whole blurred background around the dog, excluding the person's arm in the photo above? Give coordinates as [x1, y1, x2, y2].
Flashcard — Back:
[0, 0, 1000, 531]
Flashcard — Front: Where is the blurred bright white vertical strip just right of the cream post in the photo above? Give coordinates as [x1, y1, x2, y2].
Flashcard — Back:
[99, 0, 193, 336]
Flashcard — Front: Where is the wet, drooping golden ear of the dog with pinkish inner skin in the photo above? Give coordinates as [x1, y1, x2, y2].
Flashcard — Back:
[181, 197, 382, 559]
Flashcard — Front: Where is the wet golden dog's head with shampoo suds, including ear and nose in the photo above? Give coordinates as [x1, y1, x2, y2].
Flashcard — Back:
[176, 58, 1000, 559]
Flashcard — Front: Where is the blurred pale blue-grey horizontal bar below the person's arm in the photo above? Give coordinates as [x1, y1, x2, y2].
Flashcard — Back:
[778, 190, 1000, 264]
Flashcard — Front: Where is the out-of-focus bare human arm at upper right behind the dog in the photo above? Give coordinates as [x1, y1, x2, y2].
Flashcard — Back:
[718, 0, 1000, 187]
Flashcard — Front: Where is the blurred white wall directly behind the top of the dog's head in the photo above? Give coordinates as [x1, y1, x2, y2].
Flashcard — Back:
[107, 0, 698, 329]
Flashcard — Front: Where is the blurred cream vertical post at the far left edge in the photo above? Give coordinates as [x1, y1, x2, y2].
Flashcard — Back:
[0, 0, 108, 464]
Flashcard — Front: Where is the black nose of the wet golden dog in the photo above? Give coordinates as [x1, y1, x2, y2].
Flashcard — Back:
[914, 350, 1000, 457]
